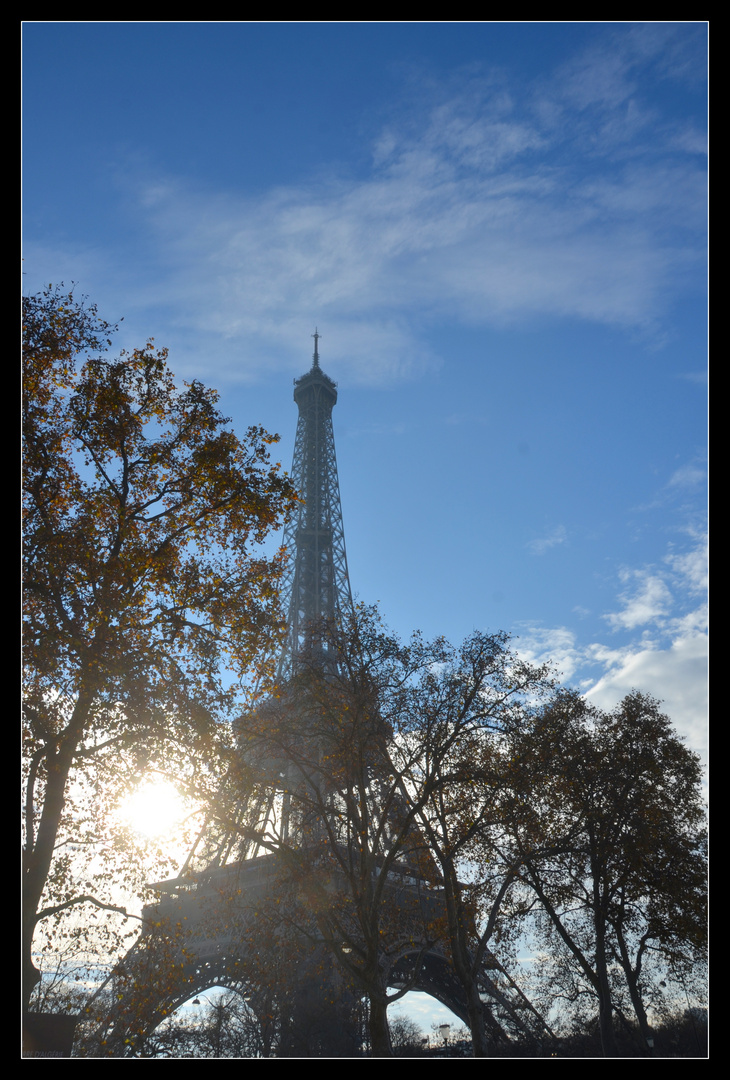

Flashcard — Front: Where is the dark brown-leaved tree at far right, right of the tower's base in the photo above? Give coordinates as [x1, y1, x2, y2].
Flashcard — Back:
[510, 691, 706, 1056]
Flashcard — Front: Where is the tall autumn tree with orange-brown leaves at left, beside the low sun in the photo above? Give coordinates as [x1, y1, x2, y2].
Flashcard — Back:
[23, 286, 294, 1003]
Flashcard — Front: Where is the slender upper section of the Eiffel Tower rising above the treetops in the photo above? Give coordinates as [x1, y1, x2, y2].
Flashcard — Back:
[279, 328, 352, 677]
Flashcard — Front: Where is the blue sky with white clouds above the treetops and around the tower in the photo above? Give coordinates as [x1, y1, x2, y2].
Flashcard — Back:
[23, 16, 707, 1041]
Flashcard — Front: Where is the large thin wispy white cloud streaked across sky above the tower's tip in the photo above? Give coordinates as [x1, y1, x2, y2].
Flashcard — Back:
[77, 28, 705, 383]
